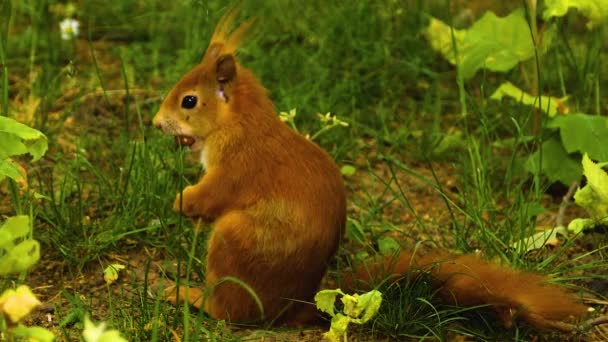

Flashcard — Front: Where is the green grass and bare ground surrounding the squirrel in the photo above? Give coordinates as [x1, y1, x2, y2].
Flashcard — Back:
[0, 0, 608, 341]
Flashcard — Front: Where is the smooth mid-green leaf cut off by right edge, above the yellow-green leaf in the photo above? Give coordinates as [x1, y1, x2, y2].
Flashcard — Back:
[547, 113, 608, 161]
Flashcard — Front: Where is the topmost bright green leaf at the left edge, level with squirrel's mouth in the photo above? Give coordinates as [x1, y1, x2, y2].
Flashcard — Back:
[0, 116, 48, 161]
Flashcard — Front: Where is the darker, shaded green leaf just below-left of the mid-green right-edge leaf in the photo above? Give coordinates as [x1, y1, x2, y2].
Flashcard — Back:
[525, 137, 582, 185]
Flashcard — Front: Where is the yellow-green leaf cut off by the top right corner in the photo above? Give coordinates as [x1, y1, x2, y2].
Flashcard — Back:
[543, 0, 608, 28]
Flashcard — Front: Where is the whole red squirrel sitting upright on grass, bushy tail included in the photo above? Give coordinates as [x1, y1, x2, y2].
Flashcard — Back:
[153, 10, 586, 328]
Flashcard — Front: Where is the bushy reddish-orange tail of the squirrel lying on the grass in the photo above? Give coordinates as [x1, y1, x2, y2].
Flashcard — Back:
[340, 251, 588, 331]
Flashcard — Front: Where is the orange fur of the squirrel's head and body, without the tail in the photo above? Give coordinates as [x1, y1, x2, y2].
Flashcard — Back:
[153, 7, 346, 322]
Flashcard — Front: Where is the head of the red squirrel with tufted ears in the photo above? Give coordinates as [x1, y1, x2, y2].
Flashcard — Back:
[152, 8, 253, 151]
